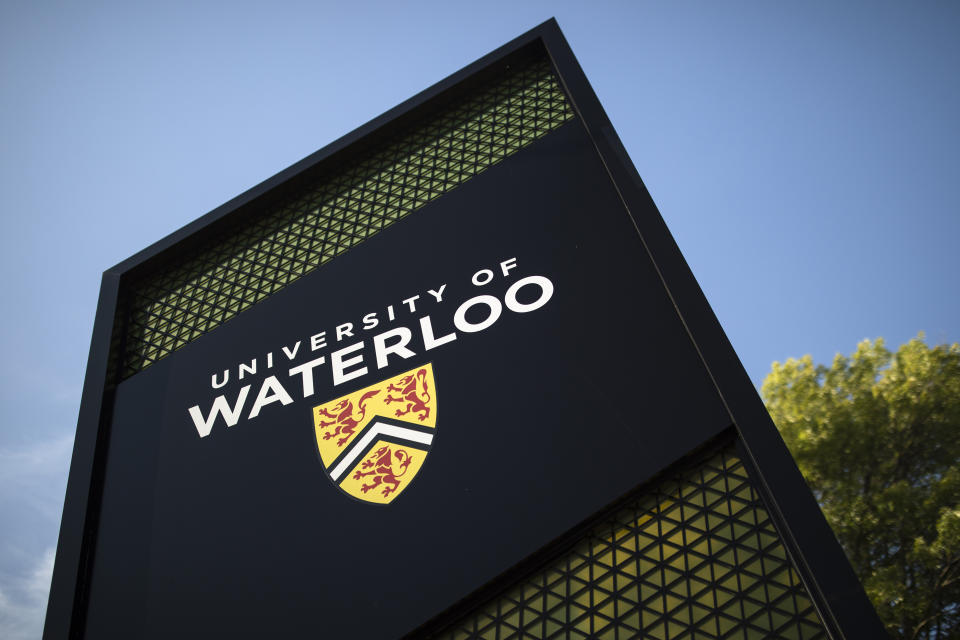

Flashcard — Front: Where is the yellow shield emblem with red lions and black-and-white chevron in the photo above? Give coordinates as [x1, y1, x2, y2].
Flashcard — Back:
[313, 363, 437, 504]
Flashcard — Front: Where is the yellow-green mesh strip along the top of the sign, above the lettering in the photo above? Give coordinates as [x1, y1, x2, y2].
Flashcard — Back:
[114, 60, 573, 378]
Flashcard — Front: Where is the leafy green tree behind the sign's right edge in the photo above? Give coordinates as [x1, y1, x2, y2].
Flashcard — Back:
[762, 334, 960, 640]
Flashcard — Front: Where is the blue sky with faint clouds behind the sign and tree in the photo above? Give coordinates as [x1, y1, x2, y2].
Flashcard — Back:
[0, 0, 960, 640]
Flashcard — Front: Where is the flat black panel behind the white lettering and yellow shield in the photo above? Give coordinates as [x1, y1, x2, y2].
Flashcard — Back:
[82, 121, 729, 638]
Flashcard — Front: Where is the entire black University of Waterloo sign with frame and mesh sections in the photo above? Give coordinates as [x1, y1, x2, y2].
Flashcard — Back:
[44, 21, 882, 640]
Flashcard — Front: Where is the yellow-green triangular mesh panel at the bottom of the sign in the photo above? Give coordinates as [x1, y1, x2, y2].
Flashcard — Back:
[434, 447, 828, 640]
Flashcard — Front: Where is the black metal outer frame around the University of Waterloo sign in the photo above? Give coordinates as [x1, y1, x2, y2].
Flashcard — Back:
[43, 19, 884, 640]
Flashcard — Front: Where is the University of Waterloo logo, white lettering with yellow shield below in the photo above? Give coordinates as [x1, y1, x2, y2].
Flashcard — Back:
[184, 257, 554, 504]
